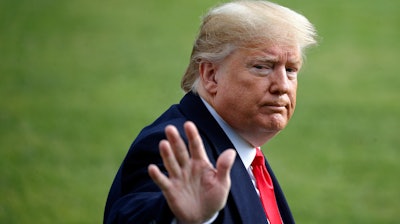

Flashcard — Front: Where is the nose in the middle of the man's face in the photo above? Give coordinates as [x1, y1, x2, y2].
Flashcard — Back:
[269, 66, 290, 95]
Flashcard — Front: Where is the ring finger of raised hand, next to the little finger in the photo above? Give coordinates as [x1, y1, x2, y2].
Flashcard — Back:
[159, 140, 181, 178]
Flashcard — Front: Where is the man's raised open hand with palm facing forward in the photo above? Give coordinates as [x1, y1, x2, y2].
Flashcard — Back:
[148, 121, 236, 223]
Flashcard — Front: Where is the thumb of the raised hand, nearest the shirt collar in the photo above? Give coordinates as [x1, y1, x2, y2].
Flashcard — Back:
[217, 149, 236, 184]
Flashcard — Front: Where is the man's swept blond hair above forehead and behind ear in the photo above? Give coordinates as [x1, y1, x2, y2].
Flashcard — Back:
[181, 0, 317, 92]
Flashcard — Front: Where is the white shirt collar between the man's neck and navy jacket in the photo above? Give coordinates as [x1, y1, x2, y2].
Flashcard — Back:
[201, 98, 256, 169]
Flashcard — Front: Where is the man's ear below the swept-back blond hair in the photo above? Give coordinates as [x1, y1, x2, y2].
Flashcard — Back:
[199, 61, 218, 94]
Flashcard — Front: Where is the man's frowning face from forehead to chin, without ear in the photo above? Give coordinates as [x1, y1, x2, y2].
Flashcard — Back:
[211, 44, 302, 146]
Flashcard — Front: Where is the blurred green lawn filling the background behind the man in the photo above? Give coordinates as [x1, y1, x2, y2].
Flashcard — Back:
[0, 0, 400, 223]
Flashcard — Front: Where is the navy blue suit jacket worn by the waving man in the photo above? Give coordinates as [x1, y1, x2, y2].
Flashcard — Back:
[104, 93, 294, 224]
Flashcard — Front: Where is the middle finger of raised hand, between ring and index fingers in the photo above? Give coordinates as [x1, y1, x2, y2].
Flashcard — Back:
[165, 125, 189, 167]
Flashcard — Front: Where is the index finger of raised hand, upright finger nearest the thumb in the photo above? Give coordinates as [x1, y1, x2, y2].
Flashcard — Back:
[184, 121, 209, 162]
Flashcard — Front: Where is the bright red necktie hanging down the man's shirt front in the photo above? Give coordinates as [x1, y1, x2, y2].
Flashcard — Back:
[251, 148, 282, 224]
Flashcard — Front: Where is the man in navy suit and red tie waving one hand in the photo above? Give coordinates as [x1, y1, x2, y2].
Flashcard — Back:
[104, 1, 316, 224]
